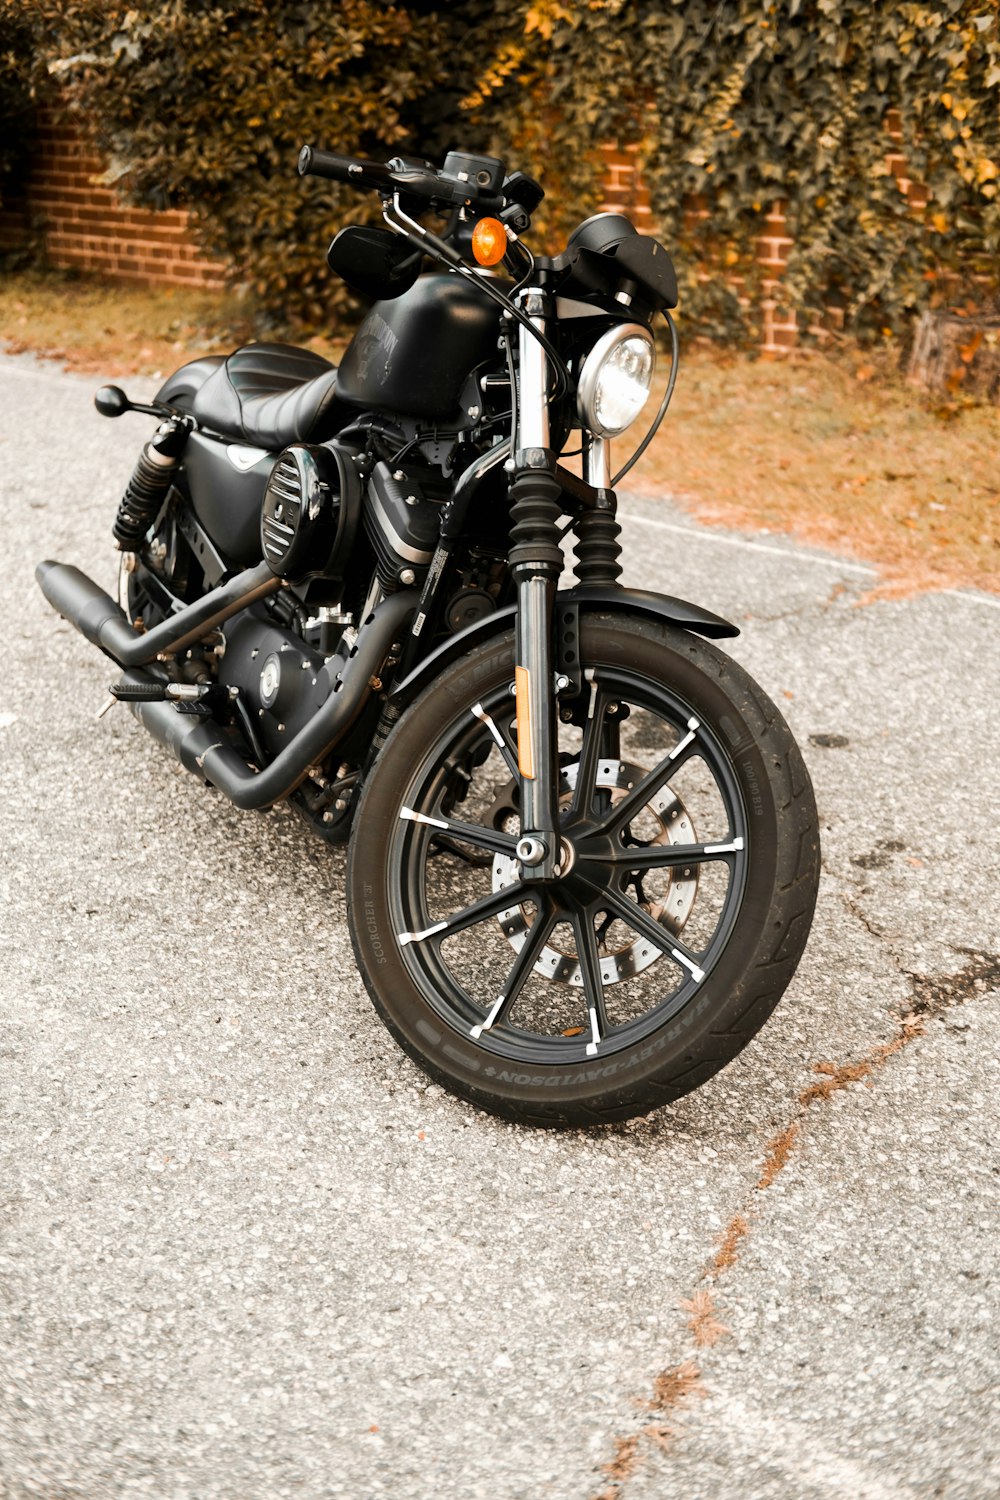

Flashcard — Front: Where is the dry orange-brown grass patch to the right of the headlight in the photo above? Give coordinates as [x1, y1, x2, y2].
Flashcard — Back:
[632, 350, 1000, 594]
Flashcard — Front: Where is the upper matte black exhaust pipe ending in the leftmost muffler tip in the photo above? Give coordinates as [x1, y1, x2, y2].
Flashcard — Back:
[34, 561, 283, 668]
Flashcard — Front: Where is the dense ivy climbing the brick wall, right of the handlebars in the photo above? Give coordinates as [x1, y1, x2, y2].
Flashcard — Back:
[469, 0, 1000, 341]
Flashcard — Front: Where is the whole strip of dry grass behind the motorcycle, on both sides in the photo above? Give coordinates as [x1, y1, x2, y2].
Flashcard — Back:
[0, 270, 1000, 594]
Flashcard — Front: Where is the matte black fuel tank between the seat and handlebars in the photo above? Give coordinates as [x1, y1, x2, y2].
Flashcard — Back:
[337, 273, 499, 426]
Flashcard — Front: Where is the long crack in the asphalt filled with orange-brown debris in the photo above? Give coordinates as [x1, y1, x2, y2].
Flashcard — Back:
[592, 942, 1000, 1500]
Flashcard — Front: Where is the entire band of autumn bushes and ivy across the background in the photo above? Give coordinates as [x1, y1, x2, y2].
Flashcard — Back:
[0, 0, 1000, 344]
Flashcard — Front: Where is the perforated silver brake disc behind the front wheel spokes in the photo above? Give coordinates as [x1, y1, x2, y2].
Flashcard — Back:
[493, 761, 699, 989]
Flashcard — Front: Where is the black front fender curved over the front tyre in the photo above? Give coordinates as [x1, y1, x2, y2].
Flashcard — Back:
[388, 584, 739, 711]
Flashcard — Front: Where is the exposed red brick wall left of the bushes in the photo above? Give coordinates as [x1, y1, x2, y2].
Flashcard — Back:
[0, 111, 225, 287]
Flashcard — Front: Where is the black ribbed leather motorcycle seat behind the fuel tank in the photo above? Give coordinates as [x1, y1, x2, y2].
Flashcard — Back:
[190, 344, 340, 452]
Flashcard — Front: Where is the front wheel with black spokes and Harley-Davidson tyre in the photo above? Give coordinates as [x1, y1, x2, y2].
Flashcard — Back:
[348, 615, 819, 1125]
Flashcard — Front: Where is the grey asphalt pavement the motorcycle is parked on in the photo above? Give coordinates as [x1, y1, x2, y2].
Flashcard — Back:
[0, 359, 1000, 1500]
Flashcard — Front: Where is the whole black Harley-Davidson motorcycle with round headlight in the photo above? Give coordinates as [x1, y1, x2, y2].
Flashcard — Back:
[37, 147, 819, 1125]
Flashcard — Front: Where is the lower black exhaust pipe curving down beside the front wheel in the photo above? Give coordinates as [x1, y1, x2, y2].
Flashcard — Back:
[129, 588, 420, 812]
